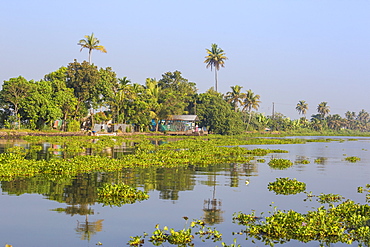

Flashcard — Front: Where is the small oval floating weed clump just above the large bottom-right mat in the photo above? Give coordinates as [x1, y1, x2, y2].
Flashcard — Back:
[267, 178, 306, 195]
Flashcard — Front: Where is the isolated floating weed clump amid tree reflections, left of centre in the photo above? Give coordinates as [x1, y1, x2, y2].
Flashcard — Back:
[98, 183, 149, 207]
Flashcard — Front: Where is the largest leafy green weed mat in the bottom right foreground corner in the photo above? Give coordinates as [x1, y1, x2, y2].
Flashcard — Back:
[233, 200, 370, 246]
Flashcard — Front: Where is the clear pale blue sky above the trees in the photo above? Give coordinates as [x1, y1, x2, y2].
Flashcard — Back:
[0, 0, 370, 119]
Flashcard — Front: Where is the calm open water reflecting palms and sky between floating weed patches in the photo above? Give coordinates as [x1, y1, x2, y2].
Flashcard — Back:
[0, 137, 370, 247]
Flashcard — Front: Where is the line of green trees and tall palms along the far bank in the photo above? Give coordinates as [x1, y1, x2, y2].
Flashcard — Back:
[0, 33, 370, 134]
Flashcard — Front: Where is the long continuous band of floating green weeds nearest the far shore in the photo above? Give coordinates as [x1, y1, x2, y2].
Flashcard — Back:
[0, 140, 253, 178]
